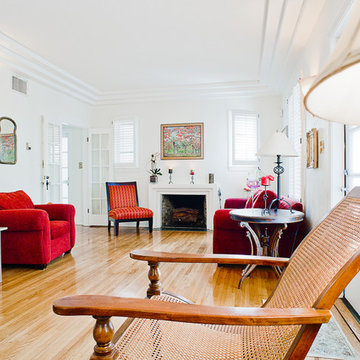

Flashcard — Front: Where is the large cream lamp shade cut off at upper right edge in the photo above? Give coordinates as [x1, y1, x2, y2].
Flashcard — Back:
[304, 0, 360, 125]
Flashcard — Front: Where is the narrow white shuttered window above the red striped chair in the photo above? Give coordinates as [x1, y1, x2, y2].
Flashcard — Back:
[114, 120, 137, 167]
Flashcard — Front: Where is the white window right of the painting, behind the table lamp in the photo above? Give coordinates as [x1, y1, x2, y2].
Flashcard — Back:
[229, 110, 259, 167]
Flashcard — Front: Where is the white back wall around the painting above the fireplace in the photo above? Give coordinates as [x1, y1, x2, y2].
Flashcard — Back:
[91, 96, 282, 210]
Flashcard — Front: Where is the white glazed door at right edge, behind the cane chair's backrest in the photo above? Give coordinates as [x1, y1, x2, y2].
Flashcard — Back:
[345, 126, 360, 314]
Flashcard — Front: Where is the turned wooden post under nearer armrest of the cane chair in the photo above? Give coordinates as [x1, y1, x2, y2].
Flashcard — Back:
[90, 316, 114, 360]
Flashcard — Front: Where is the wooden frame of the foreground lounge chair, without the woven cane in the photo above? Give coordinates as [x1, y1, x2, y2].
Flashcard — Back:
[53, 188, 360, 360]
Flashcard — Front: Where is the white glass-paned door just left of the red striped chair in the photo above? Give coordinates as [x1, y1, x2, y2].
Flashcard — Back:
[89, 129, 112, 225]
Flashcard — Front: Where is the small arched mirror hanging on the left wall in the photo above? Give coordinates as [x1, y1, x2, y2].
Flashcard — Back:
[0, 117, 17, 165]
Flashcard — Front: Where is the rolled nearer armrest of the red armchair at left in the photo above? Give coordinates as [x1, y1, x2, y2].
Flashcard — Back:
[0, 209, 49, 231]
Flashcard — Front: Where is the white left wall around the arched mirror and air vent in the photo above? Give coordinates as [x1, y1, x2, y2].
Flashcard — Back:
[0, 67, 91, 203]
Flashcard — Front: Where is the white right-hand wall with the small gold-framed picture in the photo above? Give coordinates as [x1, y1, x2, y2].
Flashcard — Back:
[284, 0, 346, 228]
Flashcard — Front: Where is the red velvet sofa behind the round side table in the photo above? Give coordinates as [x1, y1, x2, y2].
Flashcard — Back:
[213, 190, 304, 257]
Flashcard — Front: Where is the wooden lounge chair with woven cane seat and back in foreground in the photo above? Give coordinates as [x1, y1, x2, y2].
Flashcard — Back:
[53, 188, 360, 360]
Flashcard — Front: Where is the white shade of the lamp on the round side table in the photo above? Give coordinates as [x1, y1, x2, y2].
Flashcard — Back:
[256, 131, 298, 157]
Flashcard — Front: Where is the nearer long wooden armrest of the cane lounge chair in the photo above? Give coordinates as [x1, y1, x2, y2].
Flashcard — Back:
[53, 295, 331, 325]
